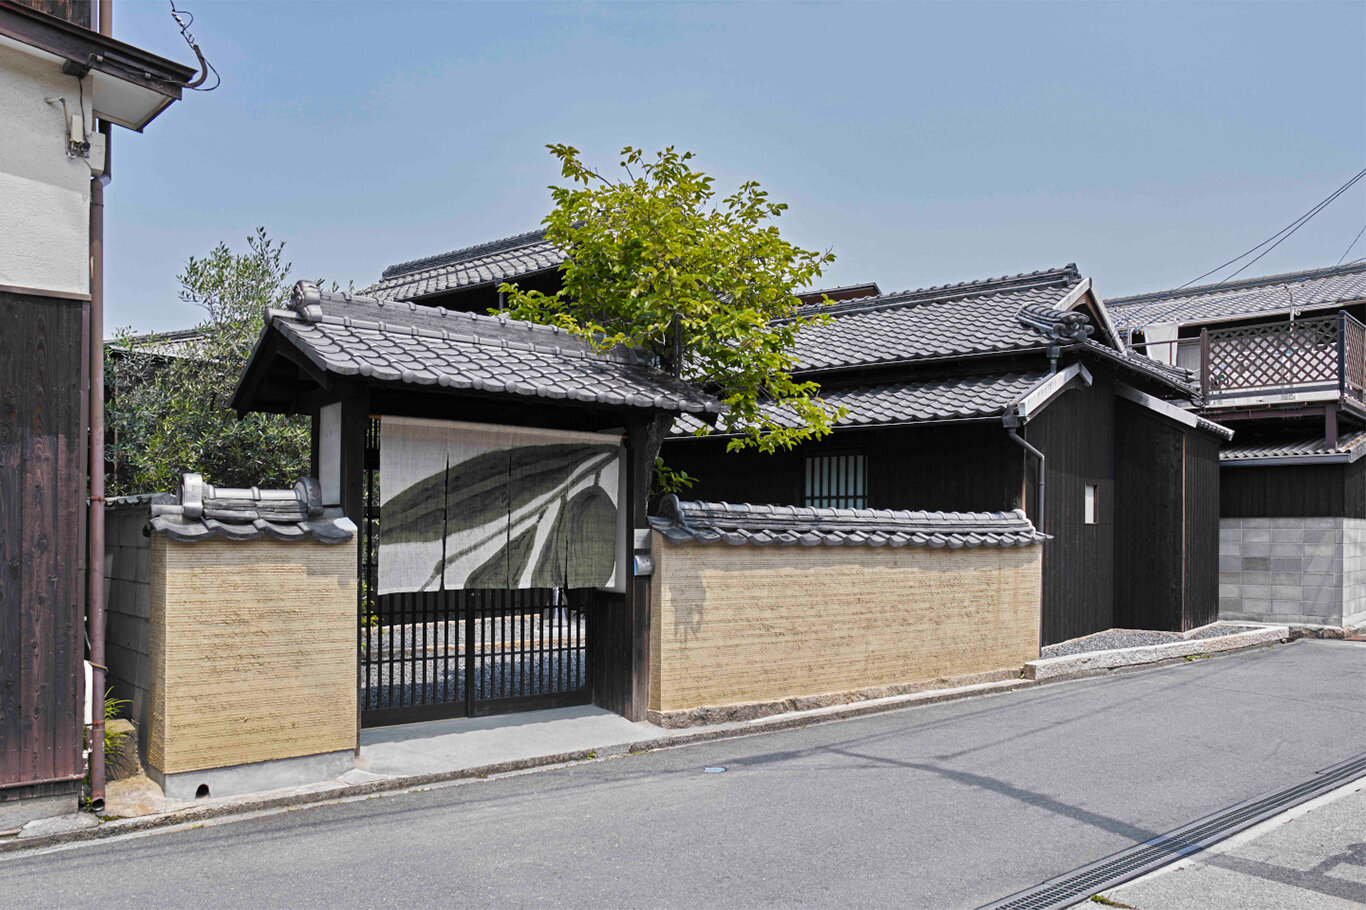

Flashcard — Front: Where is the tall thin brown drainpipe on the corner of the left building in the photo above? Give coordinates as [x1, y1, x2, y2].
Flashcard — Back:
[86, 0, 113, 812]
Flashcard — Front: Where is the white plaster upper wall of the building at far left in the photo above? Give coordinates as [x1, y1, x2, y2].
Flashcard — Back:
[0, 39, 94, 294]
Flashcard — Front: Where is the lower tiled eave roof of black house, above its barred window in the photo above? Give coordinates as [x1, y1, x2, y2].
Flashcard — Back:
[673, 370, 1048, 435]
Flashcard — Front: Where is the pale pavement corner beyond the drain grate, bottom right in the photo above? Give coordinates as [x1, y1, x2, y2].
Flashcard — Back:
[1098, 779, 1366, 910]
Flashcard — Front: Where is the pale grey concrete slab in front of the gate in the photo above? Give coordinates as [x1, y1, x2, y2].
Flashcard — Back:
[355, 705, 660, 777]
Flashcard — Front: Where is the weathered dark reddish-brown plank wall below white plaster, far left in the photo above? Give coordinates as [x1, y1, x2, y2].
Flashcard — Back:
[0, 292, 85, 798]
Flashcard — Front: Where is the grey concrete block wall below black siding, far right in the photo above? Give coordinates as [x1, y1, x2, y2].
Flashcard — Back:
[1218, 518, 1366, 626]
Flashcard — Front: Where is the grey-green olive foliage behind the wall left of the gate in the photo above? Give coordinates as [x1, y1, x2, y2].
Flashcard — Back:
[105, 228, 310, 495]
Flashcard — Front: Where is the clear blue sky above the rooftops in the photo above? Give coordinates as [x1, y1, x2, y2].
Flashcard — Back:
[107, 0, 1366, 331]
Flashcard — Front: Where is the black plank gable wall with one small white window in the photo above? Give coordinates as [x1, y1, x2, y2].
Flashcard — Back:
[1020, 370, 1115, 645]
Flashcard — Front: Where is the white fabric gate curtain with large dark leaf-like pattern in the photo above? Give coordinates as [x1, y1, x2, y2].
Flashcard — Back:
[378, 417, 623, 594]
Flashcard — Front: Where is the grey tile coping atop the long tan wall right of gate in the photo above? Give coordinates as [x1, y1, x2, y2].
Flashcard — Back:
[650, 495, 1048, 549]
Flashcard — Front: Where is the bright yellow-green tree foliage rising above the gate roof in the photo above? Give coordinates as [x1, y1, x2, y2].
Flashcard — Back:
[501, 145, 840, 491]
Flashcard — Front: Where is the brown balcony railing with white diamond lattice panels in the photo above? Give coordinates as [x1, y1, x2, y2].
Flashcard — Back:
[1199, 312, 1366, 403]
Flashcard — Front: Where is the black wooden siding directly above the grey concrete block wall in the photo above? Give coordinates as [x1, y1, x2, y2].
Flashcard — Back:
[1218, 459, 1366, 518]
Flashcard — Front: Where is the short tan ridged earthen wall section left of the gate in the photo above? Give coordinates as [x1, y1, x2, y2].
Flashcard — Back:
[148, 536, 357, 773]
